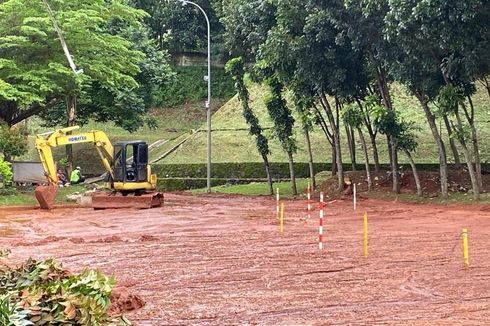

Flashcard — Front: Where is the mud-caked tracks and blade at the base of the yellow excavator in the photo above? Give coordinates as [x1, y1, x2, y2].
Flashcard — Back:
[92, 192, 163, 210]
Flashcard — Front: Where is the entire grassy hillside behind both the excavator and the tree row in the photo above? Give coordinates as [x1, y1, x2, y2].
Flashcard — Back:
[22, 85, 490, 164]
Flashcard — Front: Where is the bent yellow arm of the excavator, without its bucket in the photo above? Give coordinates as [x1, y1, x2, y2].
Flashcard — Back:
[36, 126, 114, 185]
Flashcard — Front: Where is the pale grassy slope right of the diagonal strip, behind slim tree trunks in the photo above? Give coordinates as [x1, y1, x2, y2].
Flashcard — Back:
[163, 81, 490, 164]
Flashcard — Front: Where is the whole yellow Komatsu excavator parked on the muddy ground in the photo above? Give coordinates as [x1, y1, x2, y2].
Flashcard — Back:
[35, 126, 163, 209]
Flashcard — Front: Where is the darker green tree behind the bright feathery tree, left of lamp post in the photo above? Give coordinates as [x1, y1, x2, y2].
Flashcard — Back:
[41, 23, 173, 132]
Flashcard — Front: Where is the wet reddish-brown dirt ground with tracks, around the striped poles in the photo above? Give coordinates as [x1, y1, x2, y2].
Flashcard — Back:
[0, 194, 490, 325]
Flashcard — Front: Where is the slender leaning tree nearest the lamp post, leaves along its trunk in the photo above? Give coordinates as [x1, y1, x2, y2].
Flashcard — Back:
[225, 57, 274, 195]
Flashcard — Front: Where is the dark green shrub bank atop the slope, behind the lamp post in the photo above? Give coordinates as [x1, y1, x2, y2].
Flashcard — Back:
[154, 66, 235, 107]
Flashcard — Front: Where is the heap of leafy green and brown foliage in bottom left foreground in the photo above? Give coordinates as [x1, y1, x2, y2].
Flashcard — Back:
[0, 259, 125, 325]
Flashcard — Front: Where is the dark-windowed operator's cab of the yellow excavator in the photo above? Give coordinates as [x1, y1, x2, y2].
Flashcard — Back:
[113, 141, 148, 183]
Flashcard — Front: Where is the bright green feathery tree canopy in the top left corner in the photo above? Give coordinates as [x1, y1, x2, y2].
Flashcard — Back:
[0, 0, 170, 130]
